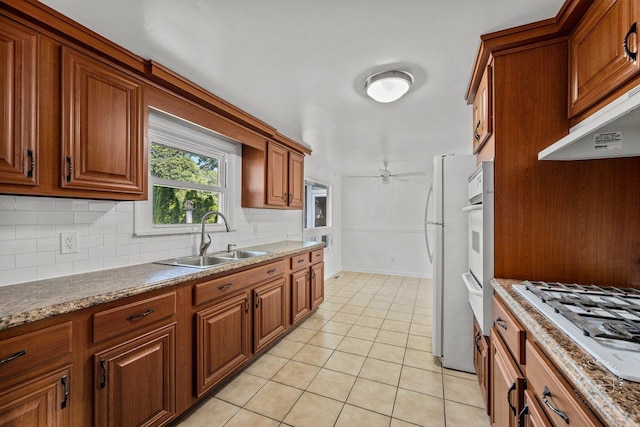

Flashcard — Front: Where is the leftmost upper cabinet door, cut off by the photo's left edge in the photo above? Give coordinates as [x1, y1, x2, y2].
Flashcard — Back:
[0, 18, 38, 185]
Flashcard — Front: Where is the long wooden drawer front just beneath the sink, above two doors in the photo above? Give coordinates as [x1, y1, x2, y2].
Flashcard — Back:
[193, 260, 286, 305]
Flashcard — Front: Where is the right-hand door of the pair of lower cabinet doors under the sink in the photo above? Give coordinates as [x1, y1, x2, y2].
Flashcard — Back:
[253, 278, 287, 353]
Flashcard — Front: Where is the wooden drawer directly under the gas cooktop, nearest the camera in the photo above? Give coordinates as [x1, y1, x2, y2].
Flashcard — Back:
[526, 342, 601, 426]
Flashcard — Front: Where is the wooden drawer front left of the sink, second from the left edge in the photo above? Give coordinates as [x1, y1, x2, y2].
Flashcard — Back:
[93, 292, 176, 343]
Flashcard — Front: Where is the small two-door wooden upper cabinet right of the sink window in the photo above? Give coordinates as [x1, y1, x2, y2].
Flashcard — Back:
[242, 141, 304, 209]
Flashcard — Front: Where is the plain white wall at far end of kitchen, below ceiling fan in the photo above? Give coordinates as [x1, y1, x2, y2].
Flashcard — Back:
[342, 175, 432, 277]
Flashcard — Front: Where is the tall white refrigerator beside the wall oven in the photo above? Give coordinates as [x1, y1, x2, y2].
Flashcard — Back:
[425, 155, 476, 373]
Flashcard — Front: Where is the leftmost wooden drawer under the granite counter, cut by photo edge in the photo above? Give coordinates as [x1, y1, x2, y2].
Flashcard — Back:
[0, 322, 72, 384]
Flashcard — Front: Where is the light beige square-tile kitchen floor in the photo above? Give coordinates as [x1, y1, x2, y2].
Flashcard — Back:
[179, 272, 490, 427]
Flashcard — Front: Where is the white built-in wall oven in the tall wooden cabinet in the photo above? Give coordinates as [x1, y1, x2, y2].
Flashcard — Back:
[462, 161, 494, 335]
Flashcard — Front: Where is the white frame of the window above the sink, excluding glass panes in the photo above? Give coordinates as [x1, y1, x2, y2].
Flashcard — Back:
[134, 108, 239, 236]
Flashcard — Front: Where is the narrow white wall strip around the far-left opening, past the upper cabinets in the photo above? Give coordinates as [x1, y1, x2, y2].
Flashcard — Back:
[305, 154, 343, 278]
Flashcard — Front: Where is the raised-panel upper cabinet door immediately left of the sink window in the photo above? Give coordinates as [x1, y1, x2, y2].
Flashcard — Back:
[61, 47, 146, 194]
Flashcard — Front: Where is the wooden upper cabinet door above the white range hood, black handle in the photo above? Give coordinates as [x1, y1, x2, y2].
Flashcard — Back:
[569, 0, 640, 118]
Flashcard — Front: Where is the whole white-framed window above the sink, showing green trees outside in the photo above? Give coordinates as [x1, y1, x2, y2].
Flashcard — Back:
[135, 110, 237, 235]
